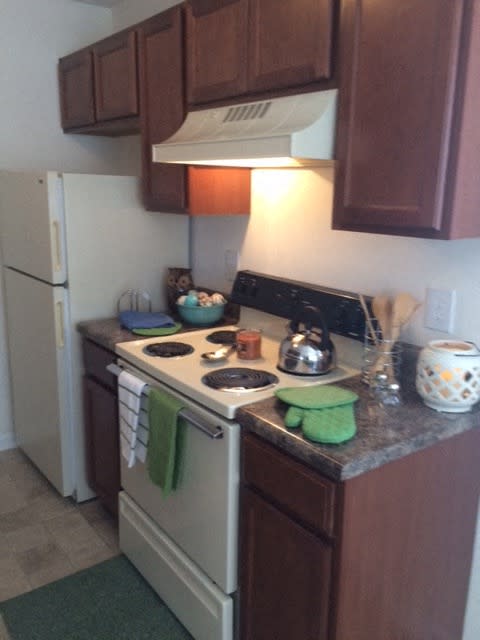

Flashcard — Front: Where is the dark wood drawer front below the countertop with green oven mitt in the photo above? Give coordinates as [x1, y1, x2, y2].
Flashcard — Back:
[242, 434, 336, 536]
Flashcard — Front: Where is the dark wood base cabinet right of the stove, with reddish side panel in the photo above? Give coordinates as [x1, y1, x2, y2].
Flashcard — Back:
[239, 429, 480, 640]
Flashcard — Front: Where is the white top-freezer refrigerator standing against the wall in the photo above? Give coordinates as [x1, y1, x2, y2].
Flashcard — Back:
[0, 171, 189, 502]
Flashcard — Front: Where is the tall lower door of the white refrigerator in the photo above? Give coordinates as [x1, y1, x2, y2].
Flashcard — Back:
[4, 269, 75, 496]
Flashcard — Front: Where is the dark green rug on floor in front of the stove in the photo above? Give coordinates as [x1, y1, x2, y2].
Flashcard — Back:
[0, 555, 193, 640]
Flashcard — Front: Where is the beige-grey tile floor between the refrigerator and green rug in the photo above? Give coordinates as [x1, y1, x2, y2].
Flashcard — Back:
[0, 449, 120, 601]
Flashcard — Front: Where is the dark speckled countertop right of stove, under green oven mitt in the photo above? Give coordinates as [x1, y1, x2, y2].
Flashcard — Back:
[237, 350, 480, 481]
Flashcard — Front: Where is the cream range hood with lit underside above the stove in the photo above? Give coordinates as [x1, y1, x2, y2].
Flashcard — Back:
[152, 89, 337, 167]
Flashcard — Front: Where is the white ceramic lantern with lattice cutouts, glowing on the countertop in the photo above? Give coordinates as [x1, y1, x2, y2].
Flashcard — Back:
[416, 340, 480, 413]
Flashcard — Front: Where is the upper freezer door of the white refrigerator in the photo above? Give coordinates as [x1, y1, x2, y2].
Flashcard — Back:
[0, 171, 67, 284]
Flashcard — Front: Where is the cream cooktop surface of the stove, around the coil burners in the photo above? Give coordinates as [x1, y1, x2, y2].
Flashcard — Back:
[116, 309, 361, 419]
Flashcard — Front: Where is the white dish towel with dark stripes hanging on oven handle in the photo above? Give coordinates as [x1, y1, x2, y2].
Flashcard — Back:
[118, 371, 148, 467]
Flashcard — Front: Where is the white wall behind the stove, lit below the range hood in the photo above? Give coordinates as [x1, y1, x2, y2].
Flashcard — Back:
[192, 168, 480, 345]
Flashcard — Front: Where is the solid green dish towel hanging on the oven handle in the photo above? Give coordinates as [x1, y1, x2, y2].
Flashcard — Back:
[147, 389, 187, 496]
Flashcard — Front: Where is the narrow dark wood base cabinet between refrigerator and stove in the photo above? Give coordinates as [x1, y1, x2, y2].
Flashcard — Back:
[82, 339, 120, 516]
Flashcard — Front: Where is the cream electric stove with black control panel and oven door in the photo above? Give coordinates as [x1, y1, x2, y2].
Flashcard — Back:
[112, 271, 364, 640]
